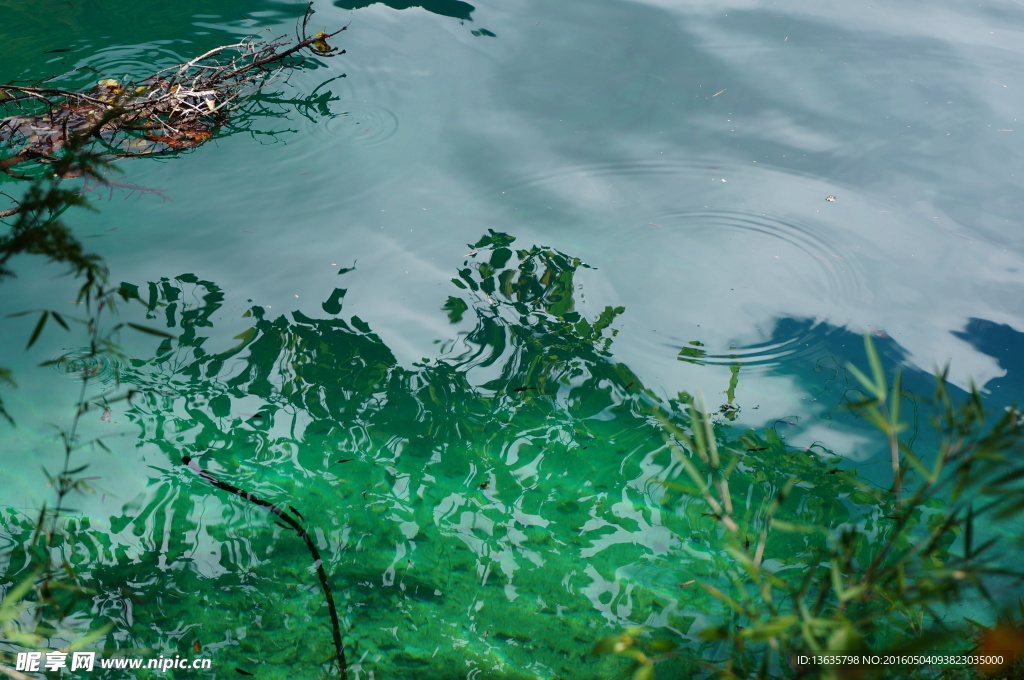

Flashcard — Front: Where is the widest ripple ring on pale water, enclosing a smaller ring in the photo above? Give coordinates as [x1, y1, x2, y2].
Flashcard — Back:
[483, 156, 870, 367]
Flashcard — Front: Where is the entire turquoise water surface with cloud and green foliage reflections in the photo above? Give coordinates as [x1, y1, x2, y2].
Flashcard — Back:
[0, 0, 1024, 678]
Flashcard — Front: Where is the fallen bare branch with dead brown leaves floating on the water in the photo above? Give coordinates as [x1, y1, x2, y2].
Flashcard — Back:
[0, 3, 348, 216]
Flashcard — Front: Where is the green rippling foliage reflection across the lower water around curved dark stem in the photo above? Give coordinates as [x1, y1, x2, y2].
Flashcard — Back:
[3, 231, 1019, 680]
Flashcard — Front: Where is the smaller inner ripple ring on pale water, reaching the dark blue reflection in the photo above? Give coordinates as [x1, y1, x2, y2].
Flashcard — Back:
[613, 209, 865, 367]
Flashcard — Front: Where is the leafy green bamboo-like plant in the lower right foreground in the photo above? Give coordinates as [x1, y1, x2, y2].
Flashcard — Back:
[594, 336, 1024, 680]
